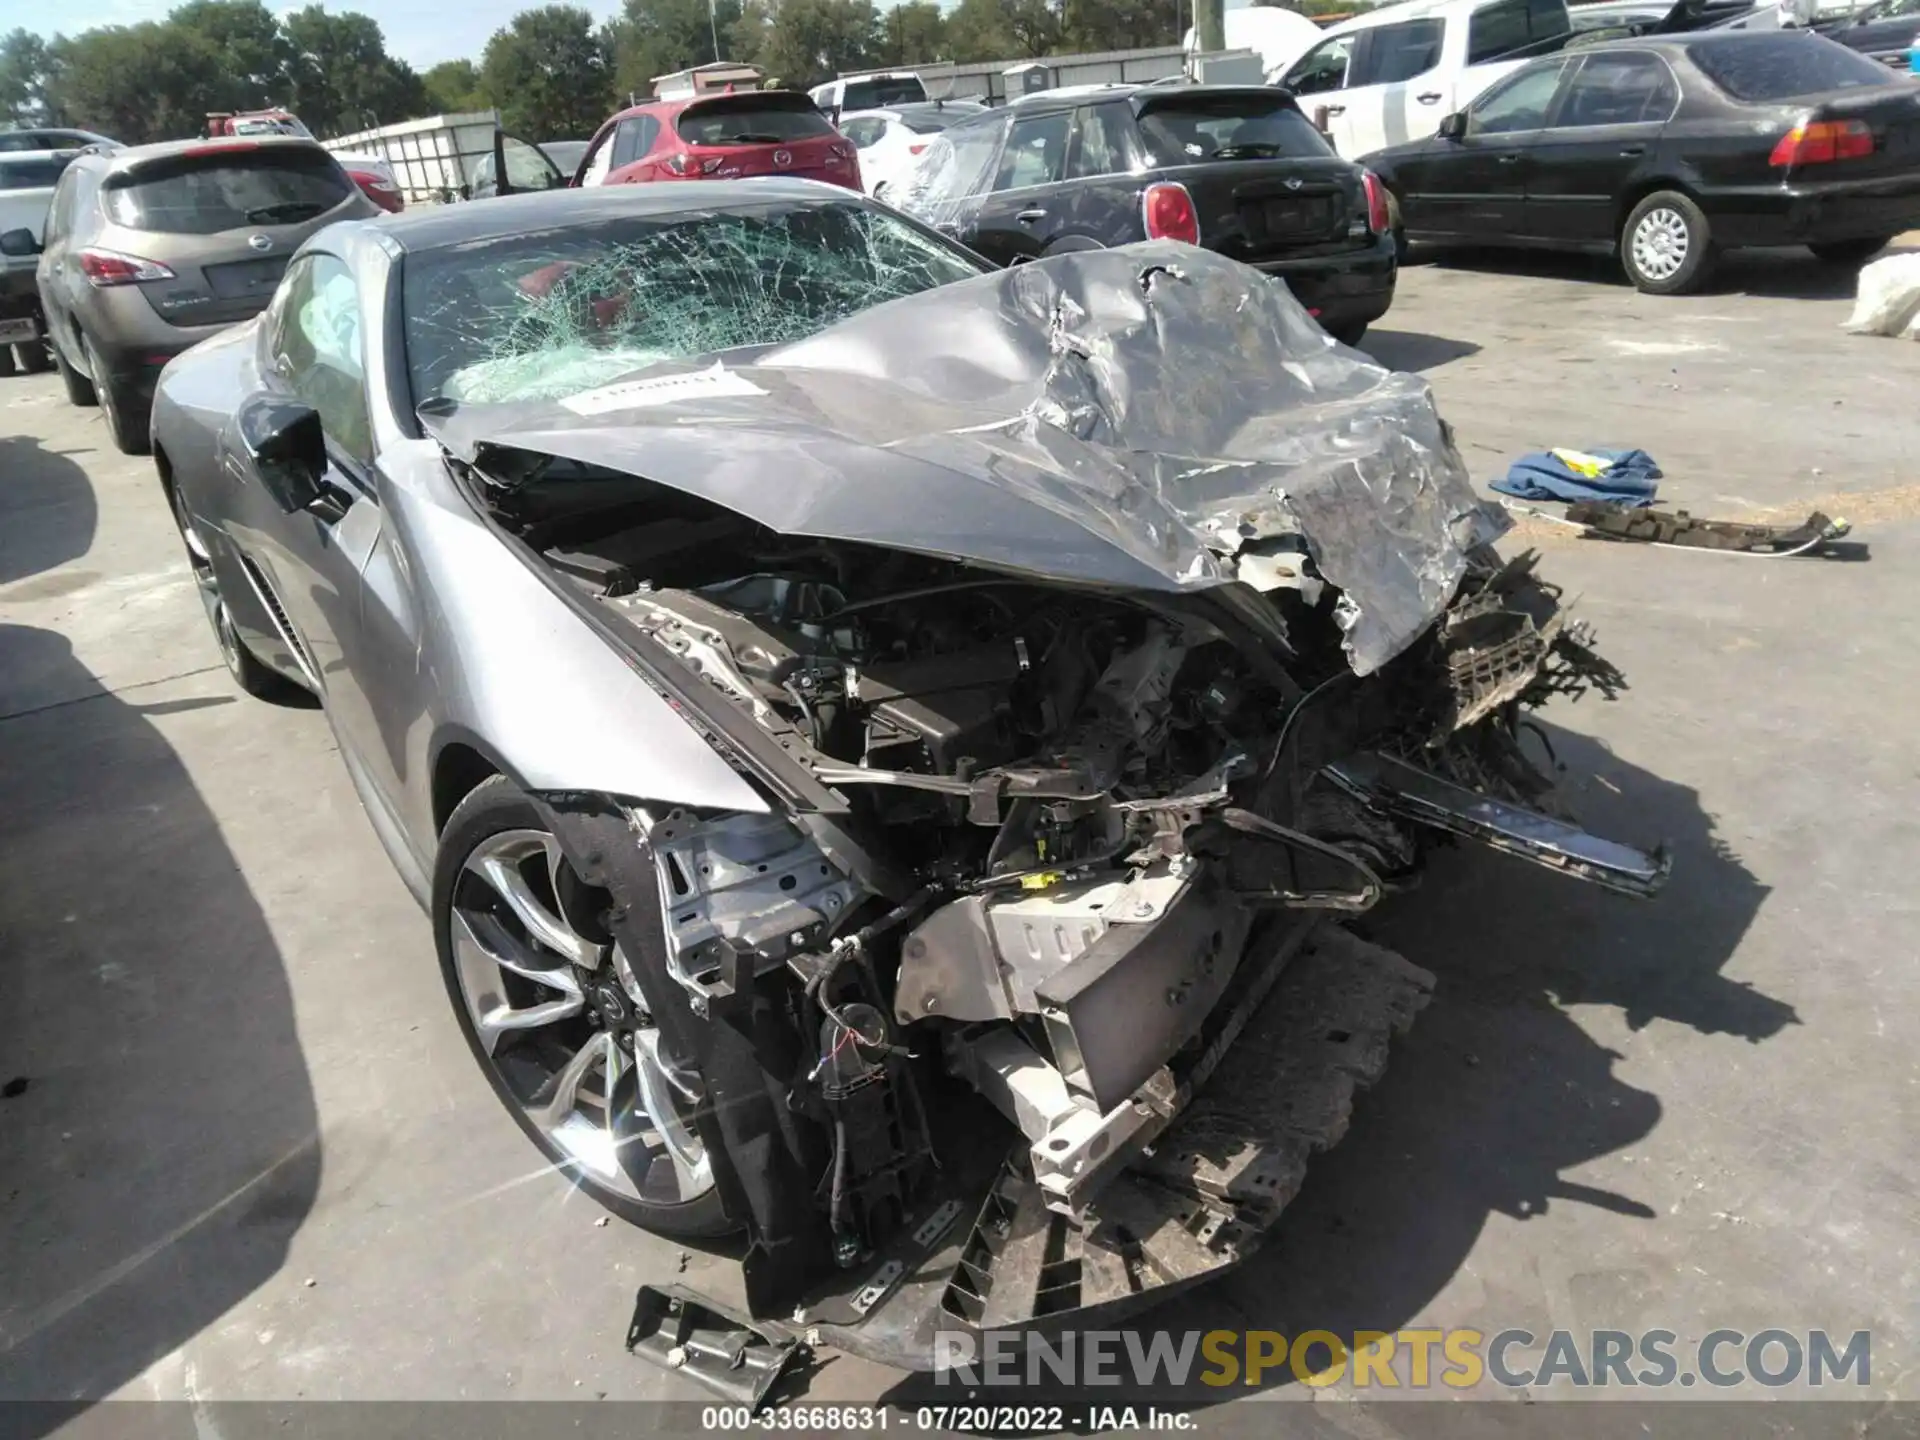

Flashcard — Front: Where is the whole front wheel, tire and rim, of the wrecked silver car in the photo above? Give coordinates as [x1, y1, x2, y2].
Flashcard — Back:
[432, 776, 733, 1236]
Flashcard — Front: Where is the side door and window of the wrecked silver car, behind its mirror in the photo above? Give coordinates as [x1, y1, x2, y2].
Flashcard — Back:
[234, 252, 382, 779]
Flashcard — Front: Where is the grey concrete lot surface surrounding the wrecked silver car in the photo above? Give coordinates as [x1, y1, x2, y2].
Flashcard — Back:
[0, 255, 1920, 1434]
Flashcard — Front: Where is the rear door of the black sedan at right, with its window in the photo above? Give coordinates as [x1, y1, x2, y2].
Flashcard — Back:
[1524, 50, 1680, 246]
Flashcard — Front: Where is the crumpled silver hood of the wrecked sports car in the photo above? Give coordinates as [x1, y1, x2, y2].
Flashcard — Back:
[422, 242, 1505, 674]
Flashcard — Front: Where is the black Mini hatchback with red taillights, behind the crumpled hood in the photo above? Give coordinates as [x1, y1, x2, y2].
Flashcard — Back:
[887, 84, 1398, 344]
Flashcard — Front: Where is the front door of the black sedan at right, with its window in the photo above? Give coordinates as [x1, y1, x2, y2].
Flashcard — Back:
[1402, 60, 1567, 242]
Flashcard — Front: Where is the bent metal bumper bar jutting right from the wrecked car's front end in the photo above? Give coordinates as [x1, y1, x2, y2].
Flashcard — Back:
[1327, 755, 1672, 899]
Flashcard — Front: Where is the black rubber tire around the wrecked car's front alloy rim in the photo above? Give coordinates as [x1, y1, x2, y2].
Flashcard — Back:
[432, 776, 739, 1238]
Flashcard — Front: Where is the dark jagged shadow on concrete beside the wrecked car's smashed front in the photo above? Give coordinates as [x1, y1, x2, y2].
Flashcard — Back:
[889, 730, 1797, 1409]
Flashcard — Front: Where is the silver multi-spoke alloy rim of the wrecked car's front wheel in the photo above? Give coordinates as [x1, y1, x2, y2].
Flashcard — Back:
[449, 829, 714, 1204]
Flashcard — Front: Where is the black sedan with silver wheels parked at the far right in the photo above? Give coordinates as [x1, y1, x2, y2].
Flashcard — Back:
[1363, 31, 1920, 296]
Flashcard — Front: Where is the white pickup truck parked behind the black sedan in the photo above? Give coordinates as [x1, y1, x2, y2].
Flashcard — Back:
[1279, 0, 1572, 159]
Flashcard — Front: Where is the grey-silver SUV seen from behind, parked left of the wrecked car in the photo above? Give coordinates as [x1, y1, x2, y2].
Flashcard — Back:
[0, 136, 380, 455]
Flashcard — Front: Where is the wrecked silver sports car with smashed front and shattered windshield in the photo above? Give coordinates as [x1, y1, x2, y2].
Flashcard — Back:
[154, 180, 1667, 1371]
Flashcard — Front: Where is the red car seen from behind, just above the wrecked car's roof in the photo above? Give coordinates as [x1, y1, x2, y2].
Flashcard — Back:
[574, 90, 860, 190]
